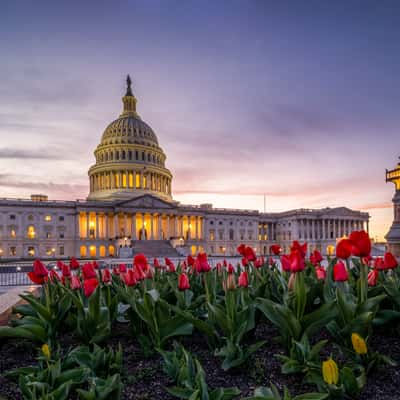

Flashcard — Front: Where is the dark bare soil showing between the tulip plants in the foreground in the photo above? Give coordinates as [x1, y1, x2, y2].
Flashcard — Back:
[0, 324, 400, 400]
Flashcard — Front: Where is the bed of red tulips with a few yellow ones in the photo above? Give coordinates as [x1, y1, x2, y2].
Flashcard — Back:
[0, 231, 400, 400]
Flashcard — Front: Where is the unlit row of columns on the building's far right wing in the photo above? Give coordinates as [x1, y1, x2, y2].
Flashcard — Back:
[298, 219, 369, 240]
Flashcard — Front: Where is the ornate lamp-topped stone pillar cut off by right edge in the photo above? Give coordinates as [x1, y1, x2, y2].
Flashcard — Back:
[385, 157, 400, 257]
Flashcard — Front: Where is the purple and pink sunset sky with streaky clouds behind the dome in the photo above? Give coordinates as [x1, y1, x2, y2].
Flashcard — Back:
[0, 0, 400, 240]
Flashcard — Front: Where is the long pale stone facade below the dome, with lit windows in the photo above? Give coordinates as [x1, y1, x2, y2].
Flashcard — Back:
[0, 195, 368, 259]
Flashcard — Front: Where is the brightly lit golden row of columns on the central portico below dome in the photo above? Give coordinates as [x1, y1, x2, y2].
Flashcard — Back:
[79, 212, 204, 240]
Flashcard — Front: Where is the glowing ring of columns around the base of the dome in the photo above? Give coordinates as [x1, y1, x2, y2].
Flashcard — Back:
[90, 170, 171, 195]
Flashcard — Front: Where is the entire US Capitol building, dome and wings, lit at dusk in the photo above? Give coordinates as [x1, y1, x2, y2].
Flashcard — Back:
[0, 76, 369, 259]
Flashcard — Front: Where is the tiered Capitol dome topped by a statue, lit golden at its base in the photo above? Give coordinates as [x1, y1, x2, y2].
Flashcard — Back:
[88, 75, 172, 201]
